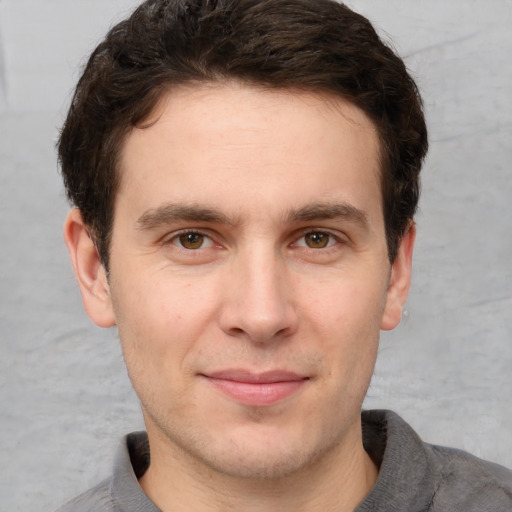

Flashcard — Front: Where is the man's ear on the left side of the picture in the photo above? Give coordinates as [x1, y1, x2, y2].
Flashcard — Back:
[64, 208, 116, 327]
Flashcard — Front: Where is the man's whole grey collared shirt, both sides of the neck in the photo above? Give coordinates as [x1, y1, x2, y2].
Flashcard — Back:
[57, 411, 512, 512]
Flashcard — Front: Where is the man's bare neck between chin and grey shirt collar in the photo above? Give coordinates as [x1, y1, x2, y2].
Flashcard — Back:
[139, 425, 378, 512]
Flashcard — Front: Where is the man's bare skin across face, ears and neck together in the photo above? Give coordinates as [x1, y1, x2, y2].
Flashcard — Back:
[64, 83, 415, 511]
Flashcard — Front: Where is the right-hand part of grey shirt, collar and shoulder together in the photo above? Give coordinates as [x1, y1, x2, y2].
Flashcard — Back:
[357, 411, 512, 512]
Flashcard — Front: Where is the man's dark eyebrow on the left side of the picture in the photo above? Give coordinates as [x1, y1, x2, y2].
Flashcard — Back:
[136, 203, 236, 230]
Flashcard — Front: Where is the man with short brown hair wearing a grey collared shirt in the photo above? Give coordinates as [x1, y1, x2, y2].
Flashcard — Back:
[54, 0, 512, 512]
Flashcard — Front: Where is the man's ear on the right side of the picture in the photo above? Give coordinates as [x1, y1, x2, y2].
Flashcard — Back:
[381, 222, 416, 331]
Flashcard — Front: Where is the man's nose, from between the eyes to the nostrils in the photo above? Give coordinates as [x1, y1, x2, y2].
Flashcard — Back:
[219, 246, 298, 343]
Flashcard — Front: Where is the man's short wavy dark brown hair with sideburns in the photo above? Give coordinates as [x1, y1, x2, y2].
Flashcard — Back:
[58, 0, 428, 268]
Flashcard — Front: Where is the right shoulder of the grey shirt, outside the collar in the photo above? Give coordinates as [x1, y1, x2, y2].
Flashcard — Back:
[425, 444, 512, 512]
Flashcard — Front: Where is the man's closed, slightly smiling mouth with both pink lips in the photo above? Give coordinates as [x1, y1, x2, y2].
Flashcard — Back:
[201, 370, 309, 407]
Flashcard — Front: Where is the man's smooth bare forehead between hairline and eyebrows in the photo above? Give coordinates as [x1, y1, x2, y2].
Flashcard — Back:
[118, 83, 381, 224]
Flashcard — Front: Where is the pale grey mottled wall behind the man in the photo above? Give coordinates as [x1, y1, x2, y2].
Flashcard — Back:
[0, 0, 512, 512]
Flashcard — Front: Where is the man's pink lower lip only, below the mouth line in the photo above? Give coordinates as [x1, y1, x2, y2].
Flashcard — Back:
[208, 378, 307, 407]
